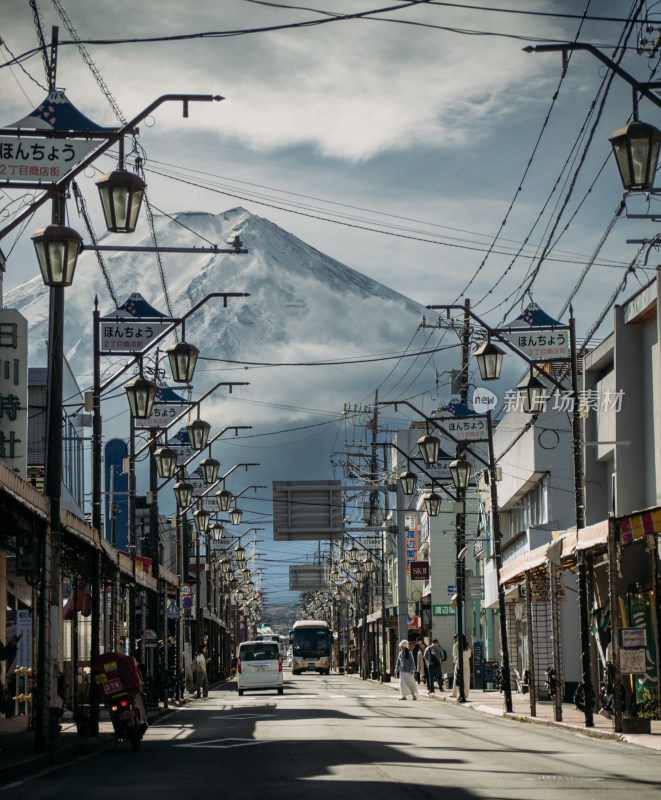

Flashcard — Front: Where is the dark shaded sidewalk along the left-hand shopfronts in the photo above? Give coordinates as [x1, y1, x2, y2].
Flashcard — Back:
[0, 700, 189, 785]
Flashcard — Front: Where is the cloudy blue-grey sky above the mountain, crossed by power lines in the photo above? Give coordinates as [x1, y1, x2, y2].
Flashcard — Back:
[0, 0, 661, 608]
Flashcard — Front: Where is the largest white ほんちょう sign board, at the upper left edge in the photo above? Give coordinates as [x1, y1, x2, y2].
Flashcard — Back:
[0, 136, 100, 183]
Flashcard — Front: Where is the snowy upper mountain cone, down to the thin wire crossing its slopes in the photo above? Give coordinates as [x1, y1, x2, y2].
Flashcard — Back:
[5, 208, 424, 399]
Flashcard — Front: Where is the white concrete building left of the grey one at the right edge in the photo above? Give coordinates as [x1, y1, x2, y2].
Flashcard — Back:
[479, 398, 580, 697]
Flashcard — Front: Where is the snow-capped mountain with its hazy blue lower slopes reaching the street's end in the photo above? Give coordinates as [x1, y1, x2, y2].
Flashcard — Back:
[4, 208, 429, 601]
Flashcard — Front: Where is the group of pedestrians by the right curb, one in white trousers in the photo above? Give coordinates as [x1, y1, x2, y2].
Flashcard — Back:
[395, 634, 471, 700]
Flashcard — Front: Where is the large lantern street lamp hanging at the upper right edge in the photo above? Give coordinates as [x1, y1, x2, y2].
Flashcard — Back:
[609, 120, 661, 192]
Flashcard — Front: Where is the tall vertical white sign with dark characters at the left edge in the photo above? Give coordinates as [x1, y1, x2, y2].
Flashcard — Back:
[0, 308, 28, 479]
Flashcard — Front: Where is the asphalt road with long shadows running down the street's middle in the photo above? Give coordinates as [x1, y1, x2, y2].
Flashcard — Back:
[2, 673, 661, 800]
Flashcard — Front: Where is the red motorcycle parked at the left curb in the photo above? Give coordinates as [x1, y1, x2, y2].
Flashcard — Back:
[92, 652, 147, 750]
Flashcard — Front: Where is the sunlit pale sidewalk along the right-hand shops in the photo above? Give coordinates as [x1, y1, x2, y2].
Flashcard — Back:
[356, 675, 661, 751]
